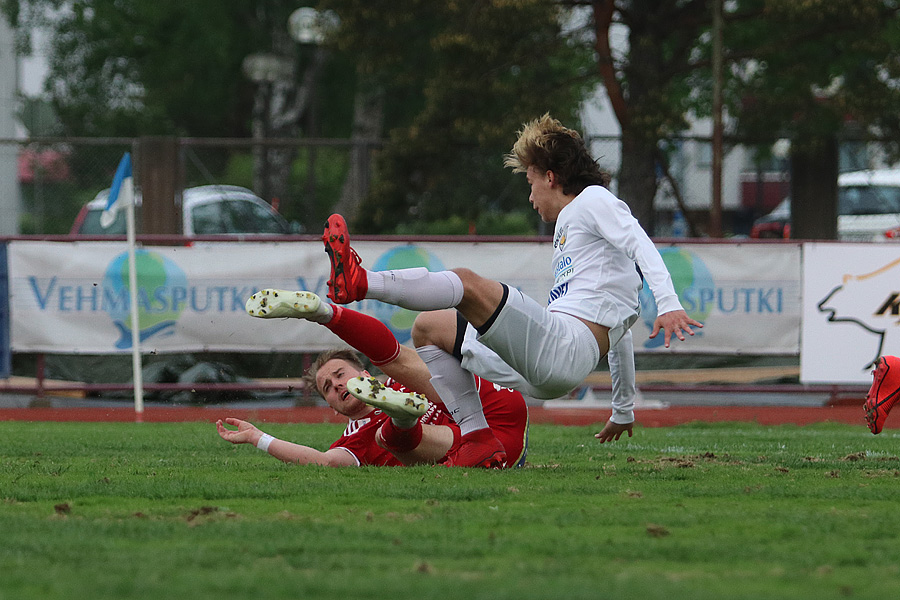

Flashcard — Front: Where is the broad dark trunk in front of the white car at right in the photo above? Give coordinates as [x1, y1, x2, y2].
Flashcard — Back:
[791, 137, 838, 240]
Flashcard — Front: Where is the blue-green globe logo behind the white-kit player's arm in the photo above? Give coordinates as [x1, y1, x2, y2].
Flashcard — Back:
[640, 248, 713, 349]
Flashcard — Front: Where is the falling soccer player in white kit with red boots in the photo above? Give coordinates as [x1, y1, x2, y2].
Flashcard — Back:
[323, 115, 703, 467]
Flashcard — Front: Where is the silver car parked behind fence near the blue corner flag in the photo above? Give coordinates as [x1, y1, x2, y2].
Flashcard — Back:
[69, 185, 299, 236]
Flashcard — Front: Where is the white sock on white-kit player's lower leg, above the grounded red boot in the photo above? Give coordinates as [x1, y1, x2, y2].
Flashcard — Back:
[416, 346, 488, 435]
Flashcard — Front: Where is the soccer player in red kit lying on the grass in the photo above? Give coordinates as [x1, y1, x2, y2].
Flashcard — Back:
[216, 290, 528, 467]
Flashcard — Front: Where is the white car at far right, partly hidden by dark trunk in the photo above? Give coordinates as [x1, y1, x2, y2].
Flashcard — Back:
[750, 169, 900, 242]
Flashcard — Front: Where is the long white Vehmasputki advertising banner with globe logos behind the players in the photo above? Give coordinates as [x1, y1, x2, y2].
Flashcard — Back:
[9, 241, 800, 354]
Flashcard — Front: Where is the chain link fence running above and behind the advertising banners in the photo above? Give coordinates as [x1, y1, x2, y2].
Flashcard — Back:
[7, 136, 900, 237]
